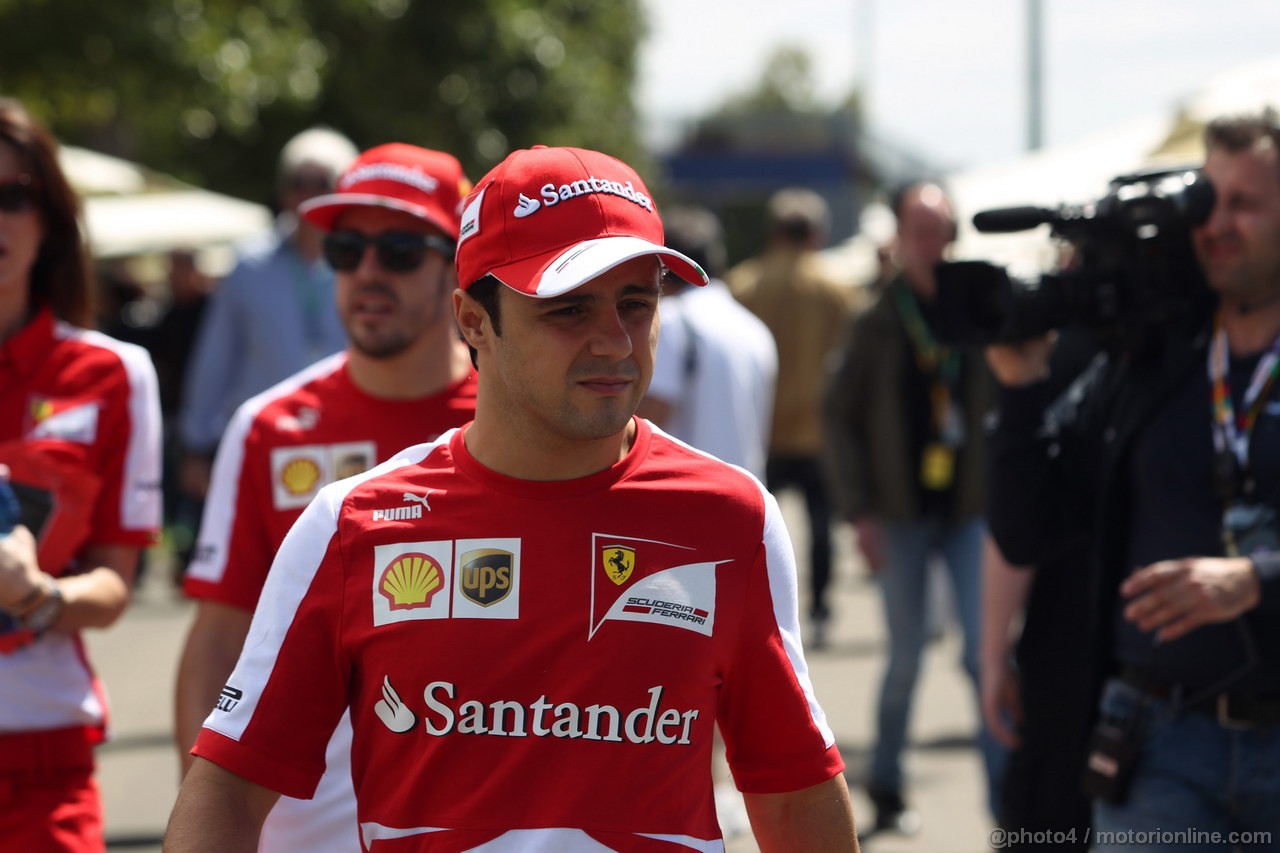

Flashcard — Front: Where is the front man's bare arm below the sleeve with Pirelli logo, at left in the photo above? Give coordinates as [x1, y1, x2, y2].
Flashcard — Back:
[164, 758, 279, 853]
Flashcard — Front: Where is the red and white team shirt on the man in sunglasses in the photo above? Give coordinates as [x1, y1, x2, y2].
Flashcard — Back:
[183, 352, 476, 853]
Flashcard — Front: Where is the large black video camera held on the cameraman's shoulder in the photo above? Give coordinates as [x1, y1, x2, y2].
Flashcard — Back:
[934, 169, 1215, 346]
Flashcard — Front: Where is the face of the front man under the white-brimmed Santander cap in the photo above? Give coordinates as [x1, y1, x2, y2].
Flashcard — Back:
[480, 256, 660, 443]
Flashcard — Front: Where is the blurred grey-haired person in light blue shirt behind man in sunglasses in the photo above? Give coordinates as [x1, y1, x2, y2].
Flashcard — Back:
[178, 127, 357, 573]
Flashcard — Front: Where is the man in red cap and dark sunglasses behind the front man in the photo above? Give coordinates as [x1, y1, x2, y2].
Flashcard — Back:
[177, 143, 476, 853]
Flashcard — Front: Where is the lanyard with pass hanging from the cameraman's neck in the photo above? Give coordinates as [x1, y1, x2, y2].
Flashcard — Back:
[1208, 316, 1280, 557]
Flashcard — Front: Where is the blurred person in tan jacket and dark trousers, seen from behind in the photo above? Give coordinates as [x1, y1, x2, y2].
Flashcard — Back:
[724, 188, 851, 647]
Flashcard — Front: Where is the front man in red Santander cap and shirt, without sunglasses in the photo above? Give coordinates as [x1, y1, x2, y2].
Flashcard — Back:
[165, 147, 858, 853]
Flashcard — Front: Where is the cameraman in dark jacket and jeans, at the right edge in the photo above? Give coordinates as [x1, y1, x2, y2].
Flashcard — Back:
[987, 110, 1280, 850]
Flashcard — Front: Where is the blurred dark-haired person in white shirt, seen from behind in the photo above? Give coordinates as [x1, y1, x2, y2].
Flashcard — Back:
[637, 207, 778, 480]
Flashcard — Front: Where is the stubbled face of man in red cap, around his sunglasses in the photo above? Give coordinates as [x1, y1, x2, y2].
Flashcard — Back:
[333, 207, 454, 359]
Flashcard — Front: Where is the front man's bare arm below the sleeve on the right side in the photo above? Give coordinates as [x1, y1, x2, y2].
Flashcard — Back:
[742, 775, 859, 853]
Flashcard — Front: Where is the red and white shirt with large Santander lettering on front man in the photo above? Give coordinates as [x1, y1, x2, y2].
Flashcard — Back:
[195, 420, 844, 852]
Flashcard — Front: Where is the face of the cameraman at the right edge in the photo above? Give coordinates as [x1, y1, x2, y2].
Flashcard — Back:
[1192, 143, 1280, 301]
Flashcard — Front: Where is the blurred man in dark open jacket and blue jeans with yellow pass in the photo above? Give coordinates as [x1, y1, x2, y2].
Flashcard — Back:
[826, 183, 1002, 833]
